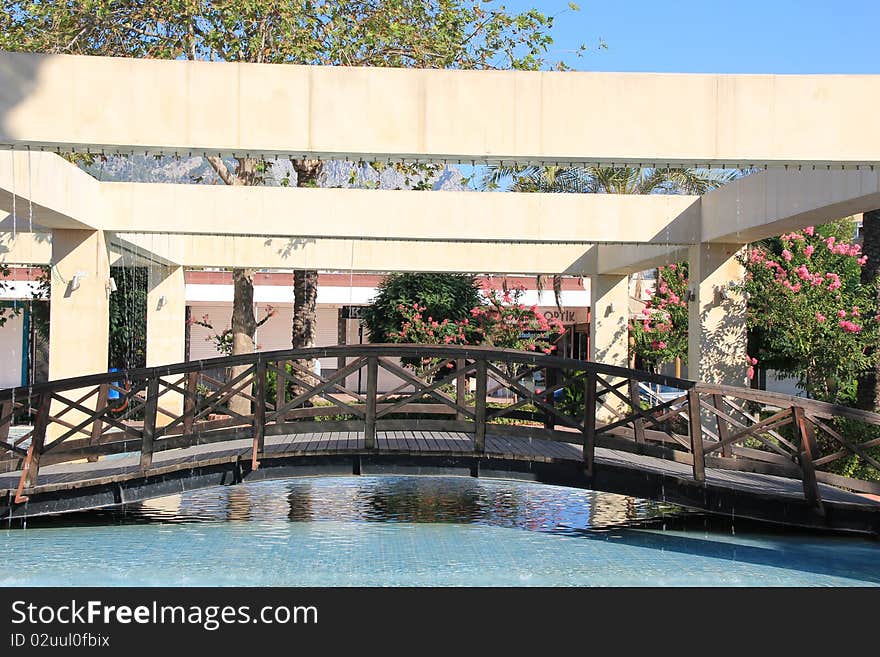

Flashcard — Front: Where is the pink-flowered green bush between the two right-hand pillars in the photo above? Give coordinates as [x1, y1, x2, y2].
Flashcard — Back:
[629, 262, 688, 368]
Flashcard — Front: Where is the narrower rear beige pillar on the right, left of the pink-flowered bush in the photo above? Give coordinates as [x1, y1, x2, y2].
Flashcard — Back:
[590, 275, 629, 422]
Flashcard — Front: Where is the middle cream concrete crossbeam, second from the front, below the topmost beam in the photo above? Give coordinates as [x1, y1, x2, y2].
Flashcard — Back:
[100, 183, 700, 244]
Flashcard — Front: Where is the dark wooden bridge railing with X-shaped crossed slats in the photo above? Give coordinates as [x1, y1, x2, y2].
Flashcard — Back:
[0, 345, 880, 509]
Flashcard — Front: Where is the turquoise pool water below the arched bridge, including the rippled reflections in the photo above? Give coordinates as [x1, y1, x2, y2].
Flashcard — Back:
[0, 477, 880, 586]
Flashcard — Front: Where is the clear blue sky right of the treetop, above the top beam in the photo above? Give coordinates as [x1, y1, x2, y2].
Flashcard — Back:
[503, 0, 880, 73]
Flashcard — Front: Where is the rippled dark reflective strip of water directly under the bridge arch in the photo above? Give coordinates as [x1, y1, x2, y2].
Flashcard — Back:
[58, 477, 685, 531]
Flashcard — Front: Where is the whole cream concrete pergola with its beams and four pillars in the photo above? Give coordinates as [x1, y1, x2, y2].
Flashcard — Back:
[0, 53, 880, 392]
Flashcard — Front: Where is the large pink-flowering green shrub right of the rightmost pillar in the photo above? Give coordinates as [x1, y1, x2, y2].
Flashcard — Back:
[740, 221, 880, 403]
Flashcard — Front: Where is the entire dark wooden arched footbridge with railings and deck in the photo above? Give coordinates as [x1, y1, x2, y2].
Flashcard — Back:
[0, 345, 880, 534]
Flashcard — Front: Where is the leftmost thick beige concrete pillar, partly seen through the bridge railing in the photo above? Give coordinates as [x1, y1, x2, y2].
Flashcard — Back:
[47, 229, 110, 438]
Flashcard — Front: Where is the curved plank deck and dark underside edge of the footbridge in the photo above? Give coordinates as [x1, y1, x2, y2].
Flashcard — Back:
[0, 430, 880, 529]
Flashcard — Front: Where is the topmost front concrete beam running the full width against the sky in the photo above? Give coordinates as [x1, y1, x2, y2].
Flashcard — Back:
[0, 53, 880, 166]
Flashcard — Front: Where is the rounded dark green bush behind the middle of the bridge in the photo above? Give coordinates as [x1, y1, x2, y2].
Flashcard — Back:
[363, 273, 480, 342]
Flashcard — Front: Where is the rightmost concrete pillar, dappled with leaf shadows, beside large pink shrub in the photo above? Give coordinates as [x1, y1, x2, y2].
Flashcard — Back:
[688, 243, 748, 386]
